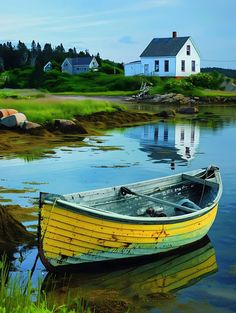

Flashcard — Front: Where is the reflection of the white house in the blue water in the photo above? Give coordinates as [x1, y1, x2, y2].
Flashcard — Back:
[126, 123, 200, 162]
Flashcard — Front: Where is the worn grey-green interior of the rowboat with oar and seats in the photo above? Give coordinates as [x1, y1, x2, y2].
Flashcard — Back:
[51, 168, 219, 217]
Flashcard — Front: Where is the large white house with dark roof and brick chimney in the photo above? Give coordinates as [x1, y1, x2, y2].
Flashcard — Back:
[125, 32, 200, 77]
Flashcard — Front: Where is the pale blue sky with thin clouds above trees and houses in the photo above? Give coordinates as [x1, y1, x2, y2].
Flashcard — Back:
[0, 0, 236, 69]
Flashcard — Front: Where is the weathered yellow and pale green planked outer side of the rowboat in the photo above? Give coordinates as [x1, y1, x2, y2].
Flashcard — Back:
[40, 199, 218, 268]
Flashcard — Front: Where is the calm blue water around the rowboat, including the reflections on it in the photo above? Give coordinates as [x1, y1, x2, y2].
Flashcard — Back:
[0, 107, 236, 313]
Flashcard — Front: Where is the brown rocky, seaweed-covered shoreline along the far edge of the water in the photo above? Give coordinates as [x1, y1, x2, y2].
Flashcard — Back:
[0, 93, 236, 135]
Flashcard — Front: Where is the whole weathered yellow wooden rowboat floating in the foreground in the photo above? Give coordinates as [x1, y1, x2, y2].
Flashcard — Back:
[39, 166, 222, 270]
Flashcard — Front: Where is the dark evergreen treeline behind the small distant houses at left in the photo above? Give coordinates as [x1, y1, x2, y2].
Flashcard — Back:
[0, 40, 101, 72]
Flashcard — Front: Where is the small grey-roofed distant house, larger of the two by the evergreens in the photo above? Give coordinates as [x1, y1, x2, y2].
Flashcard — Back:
[61, 56, 99, 75]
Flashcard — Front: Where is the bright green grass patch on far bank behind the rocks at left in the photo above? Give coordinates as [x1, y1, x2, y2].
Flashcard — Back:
[0, 98, 125, 124]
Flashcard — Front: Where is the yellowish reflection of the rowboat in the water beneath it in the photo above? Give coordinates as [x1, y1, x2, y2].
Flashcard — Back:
[43, 236, 217, 312]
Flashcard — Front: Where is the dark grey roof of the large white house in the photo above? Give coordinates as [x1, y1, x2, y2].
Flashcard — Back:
[140, 37, 190, 57]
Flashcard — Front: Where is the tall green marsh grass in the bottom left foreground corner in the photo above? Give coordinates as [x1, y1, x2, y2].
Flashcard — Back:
[0, 256, 91, 313]
